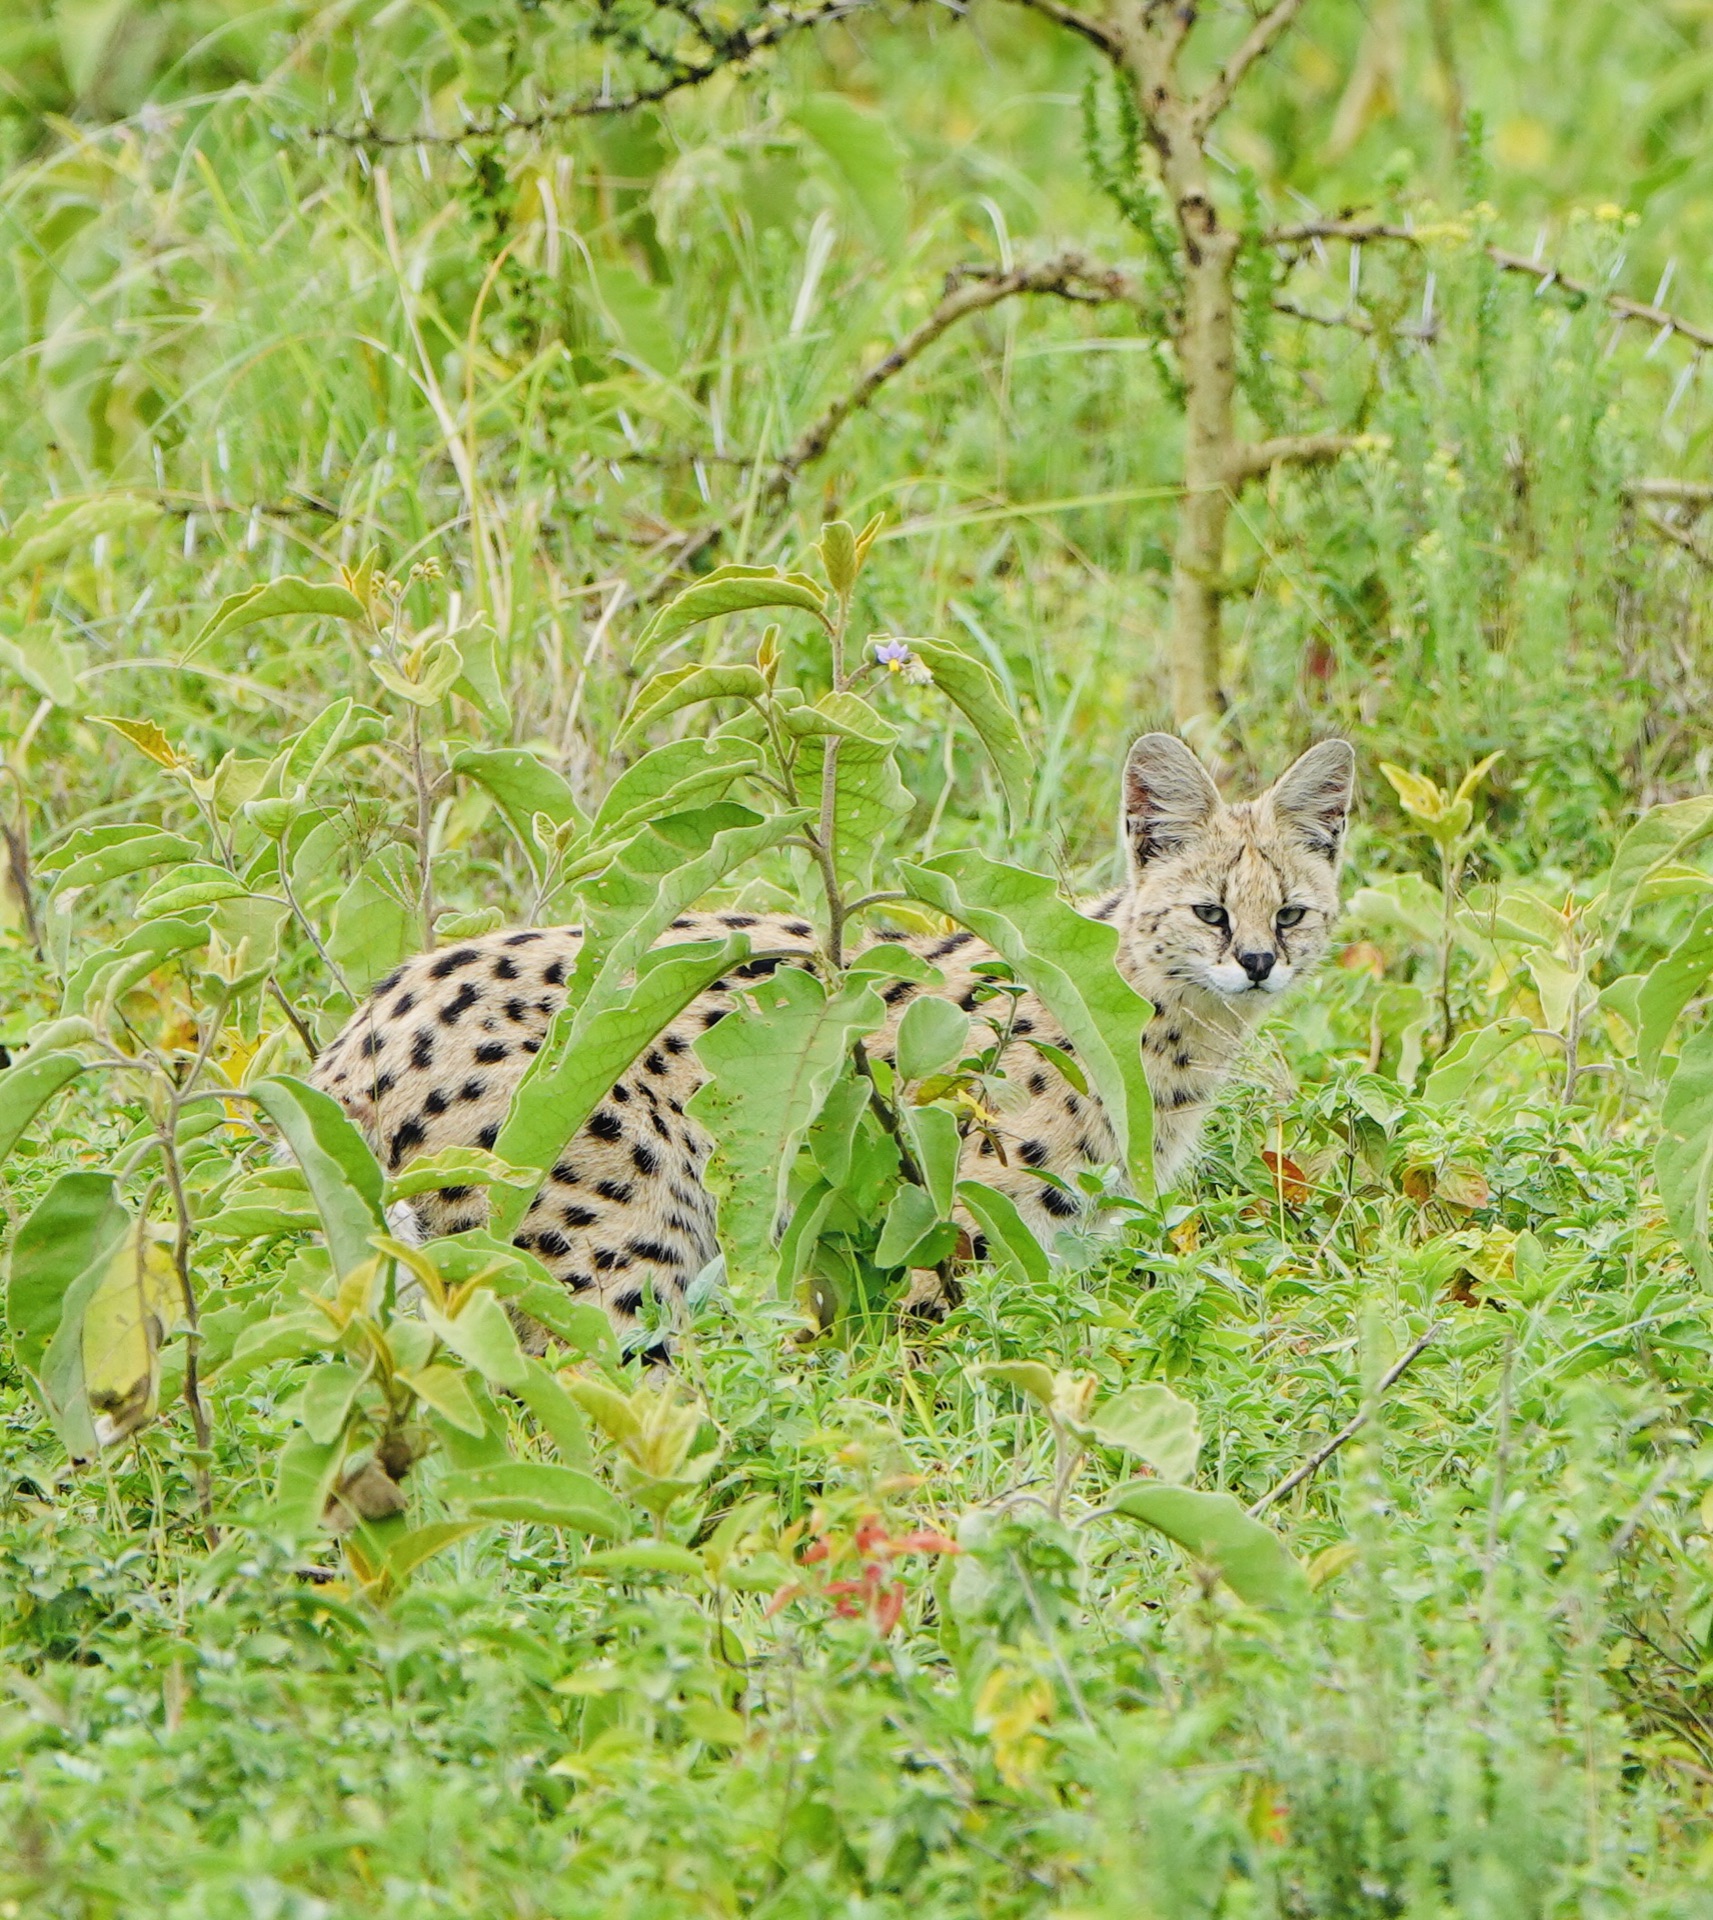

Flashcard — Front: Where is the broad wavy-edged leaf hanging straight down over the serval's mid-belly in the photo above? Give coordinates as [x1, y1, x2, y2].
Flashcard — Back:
[688, 968, 885, 1290]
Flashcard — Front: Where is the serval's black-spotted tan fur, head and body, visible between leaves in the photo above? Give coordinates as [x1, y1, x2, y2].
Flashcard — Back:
[313, 733, 1354, 1325]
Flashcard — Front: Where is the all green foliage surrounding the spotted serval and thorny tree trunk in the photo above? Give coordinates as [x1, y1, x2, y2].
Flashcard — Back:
[0, 0, 1713, 1920]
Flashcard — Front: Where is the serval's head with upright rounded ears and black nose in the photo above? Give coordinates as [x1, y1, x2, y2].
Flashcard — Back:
[1120, 733, 1356, 1010]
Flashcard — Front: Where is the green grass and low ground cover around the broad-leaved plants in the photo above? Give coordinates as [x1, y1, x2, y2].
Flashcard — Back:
[0, 0, 1713, 1920]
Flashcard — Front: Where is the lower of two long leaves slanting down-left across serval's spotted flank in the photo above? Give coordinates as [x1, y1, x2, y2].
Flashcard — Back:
[490, 939, 749, 1235]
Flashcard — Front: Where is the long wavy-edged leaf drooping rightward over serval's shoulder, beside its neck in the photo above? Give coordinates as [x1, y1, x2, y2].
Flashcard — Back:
[899, 852, 1154, 1194]
